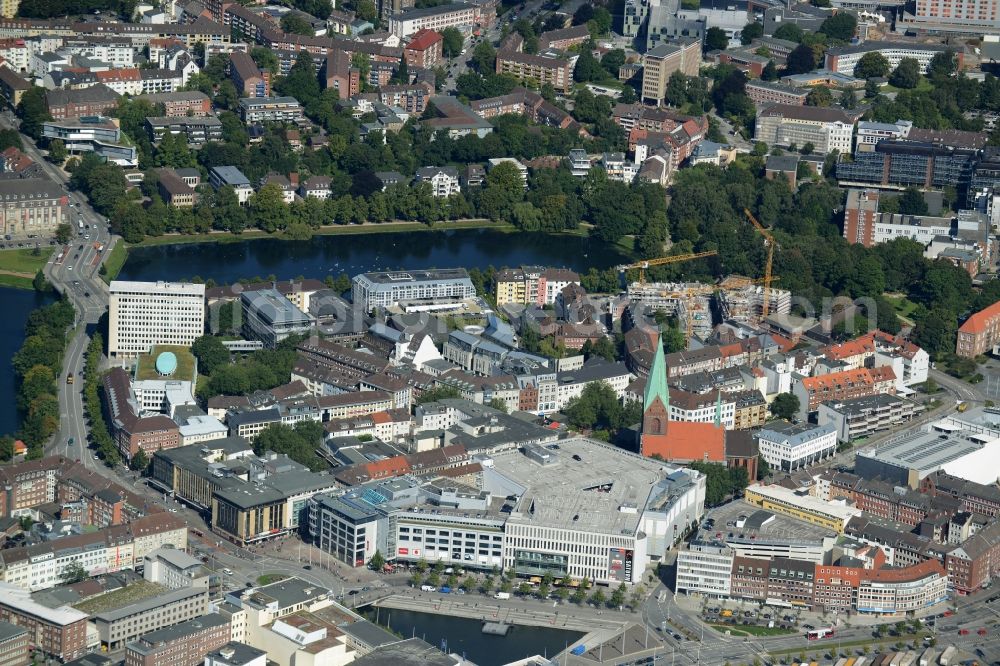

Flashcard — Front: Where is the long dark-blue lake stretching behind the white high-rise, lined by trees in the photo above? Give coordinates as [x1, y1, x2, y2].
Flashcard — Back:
[118, 229, 627, 284]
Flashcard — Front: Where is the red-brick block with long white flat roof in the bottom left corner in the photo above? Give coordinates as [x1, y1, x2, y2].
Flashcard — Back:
[0, 583, 88, 662]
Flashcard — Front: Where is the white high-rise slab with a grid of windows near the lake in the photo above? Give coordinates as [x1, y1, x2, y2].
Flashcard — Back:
[108, 280, 205, 358]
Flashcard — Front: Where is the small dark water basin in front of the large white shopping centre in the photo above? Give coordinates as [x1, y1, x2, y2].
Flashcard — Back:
[365, 607, 583, 666]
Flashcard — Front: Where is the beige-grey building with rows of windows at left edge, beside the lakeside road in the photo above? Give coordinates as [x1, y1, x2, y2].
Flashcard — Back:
[0, 178, 69, 238]
